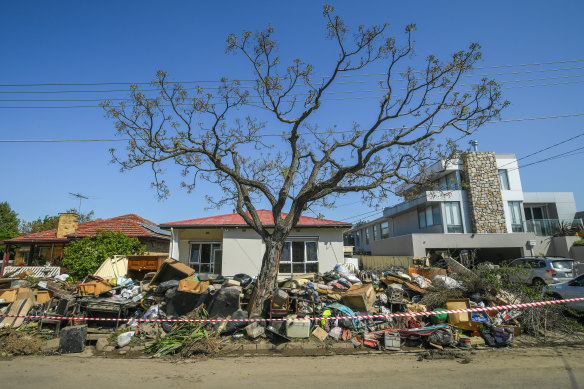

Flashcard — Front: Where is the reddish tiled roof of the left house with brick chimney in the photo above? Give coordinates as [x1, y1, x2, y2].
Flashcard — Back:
[7, 213, 170, 243]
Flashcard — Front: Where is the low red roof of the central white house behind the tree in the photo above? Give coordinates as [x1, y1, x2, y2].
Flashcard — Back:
[160, 209, 351, 228]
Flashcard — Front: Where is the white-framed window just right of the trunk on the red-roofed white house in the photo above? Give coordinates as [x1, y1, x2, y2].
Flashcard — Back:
[278, 241, 318, 274]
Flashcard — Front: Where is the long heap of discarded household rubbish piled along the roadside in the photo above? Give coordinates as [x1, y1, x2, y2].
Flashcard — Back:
[0, 256, 522, 356]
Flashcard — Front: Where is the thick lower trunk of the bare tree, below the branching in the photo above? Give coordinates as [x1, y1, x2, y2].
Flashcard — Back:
[248, 235, 285, 315]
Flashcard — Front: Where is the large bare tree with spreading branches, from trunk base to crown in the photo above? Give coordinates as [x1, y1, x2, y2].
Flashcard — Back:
[103, 6, 507, 312]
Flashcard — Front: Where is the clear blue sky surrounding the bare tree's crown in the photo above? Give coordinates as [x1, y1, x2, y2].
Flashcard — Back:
[0, 1, 584, 223]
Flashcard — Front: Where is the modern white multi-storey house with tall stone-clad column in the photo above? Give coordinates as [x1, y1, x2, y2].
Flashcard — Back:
[346, 151, 582, 261]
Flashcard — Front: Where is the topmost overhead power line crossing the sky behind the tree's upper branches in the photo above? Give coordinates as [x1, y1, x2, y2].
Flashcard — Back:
[0, 59, 584, 87]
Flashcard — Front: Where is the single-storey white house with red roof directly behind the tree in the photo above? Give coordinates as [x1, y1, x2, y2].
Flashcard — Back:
[160, 210, 351, 276]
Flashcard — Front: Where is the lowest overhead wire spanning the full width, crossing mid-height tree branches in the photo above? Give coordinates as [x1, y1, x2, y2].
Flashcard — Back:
[0, 113, 584, 143]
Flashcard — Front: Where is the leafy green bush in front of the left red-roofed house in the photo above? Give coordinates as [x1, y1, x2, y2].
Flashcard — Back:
[62, 231, 145, 280]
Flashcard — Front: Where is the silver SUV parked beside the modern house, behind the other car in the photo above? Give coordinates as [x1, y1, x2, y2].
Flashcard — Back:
[509, 257, 577, 286]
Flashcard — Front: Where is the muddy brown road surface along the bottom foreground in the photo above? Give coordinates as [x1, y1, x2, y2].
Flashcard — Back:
[0, 345, 584, 388]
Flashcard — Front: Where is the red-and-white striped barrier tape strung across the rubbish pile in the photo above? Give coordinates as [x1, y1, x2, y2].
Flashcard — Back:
[0, 297, 584, 323]
